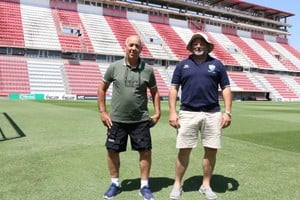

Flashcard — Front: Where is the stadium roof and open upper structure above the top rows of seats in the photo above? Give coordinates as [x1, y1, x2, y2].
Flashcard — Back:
[85, 0, 295, 36]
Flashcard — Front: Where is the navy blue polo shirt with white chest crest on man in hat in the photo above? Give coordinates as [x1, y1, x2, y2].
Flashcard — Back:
[171, 56, 230, 112]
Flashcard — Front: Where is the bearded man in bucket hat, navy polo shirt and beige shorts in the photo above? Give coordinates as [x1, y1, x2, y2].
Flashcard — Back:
[169, 32, 232, 200]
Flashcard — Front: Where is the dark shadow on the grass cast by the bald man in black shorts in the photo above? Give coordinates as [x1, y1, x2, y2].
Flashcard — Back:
[121, 177, 174, 192]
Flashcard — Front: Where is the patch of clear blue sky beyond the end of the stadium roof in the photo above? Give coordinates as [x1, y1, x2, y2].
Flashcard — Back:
[243, 0, 300, 51]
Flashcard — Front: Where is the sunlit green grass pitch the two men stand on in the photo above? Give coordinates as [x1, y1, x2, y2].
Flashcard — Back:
[0, 99, 300, 200]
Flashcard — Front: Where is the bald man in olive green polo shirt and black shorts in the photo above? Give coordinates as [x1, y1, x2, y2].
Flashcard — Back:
[98, 35, 160, 200]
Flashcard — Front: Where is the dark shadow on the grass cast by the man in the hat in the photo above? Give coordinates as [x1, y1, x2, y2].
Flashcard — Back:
[183, 174, 239, 193]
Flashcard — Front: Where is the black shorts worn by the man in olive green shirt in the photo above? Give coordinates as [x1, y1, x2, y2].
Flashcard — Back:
[105, 121, 153, 152]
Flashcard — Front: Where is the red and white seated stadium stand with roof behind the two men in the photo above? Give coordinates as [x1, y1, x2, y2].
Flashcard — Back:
[0, 0, 300, 101]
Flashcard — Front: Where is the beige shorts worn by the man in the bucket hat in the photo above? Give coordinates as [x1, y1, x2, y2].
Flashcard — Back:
[176, 110, 222, 149]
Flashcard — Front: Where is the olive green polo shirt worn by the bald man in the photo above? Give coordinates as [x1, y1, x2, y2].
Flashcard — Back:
[104, 59, 156, 123]
